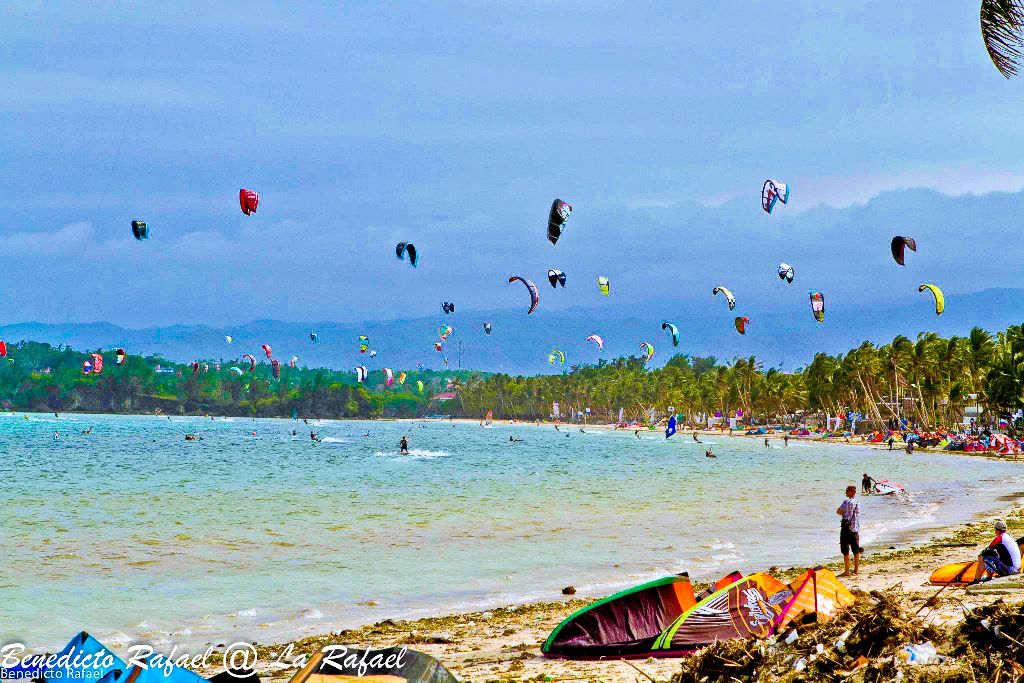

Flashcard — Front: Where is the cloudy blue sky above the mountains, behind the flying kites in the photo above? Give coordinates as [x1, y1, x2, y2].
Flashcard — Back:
[0, 0, 1024, 327]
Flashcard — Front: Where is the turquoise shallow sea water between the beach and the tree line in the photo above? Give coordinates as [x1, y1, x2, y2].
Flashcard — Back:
[0, 415, 1024, 649]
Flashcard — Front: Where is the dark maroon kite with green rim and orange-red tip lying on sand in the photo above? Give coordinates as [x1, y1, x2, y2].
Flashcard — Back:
[541, 574, 696, 657]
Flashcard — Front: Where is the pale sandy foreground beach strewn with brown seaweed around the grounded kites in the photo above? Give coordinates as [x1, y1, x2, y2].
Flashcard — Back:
[188, 495, 1024, 683]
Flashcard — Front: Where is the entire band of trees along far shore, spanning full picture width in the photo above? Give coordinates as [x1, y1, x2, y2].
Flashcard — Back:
[0, 326, 1024, 430]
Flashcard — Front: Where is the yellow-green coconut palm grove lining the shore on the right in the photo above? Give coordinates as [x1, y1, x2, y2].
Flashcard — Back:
[458, 327, 1024, 426]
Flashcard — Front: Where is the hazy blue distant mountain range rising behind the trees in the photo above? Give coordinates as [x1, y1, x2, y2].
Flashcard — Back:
[0, 289, 1024, 375]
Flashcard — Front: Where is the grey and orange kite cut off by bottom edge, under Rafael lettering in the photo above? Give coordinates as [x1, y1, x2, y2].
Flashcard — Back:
[289, 645, 459, 683]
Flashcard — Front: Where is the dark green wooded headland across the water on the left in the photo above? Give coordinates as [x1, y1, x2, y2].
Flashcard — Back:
[0, 342, 469, 418]
